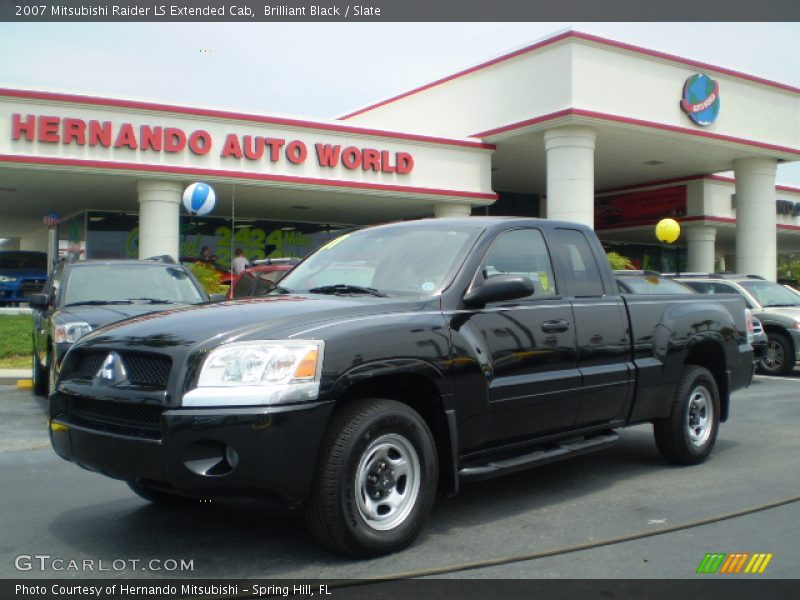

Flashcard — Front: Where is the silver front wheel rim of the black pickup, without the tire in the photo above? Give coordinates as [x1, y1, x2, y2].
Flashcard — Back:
[355, 433, 420, 531]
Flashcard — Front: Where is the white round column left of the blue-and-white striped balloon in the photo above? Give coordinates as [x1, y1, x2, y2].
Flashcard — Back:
[136, 179, 183, 260]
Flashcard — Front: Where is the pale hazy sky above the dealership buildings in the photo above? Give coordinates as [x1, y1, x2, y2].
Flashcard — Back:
[0, 22, 800, 186]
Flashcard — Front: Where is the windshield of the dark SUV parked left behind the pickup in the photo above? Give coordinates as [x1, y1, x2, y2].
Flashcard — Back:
[64, 264, 205, 305]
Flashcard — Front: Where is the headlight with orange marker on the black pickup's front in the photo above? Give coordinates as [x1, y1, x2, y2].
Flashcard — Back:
[183, 340, 325, 406]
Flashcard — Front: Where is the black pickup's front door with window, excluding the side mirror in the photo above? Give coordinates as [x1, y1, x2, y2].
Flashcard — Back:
[469, 228, 580, 440]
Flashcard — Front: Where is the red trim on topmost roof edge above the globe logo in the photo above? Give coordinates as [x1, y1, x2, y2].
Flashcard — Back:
[339, 31, 800, 121]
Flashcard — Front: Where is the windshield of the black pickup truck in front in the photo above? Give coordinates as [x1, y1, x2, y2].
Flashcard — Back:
[278, 224, 480, 296]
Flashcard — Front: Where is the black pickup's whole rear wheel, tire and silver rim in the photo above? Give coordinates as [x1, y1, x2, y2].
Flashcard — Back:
[653, 365, 720, 465]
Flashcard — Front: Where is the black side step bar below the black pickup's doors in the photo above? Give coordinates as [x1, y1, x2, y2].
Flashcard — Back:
[458, 431, 619, 481]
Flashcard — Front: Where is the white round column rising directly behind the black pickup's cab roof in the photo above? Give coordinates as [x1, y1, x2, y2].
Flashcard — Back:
[544, 126, 596, 229]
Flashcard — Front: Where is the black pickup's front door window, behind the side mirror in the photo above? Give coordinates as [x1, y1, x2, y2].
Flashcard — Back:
[481, 229, 556, 298]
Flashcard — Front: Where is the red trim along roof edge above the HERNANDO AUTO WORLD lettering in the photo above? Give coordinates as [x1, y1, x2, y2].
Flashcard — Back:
[0, 88, 495, 150]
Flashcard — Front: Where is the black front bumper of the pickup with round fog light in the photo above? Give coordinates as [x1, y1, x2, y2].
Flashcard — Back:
[50, 392, 333, 505]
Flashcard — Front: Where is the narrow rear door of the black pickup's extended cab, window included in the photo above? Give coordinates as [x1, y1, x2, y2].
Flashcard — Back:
[552, 228, 634, 426]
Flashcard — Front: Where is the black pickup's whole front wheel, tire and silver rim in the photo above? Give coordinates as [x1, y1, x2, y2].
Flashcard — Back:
[305, 399, 439, 557]
